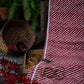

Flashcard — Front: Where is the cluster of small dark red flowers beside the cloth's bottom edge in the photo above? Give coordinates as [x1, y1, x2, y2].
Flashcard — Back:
[0, 58, 38, 84]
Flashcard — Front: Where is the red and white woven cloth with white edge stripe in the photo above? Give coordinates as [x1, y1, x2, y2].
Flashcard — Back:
[27, 0, 84, 84]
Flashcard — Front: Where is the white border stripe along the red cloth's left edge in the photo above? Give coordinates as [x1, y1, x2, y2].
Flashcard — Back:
[31, 0, 50, 81]
